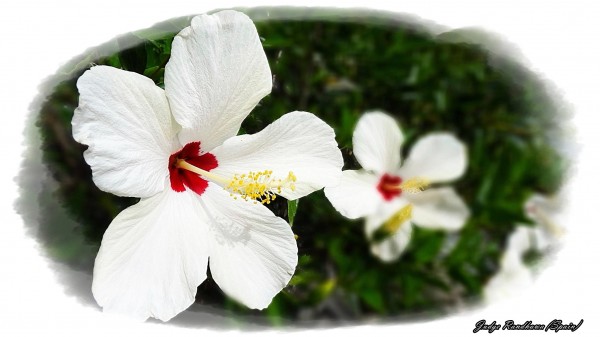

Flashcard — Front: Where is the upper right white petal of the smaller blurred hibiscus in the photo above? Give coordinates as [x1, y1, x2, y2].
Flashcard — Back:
[400, 133, 467, 182]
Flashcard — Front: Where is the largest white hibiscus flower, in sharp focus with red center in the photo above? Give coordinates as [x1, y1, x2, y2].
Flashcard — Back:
[72, 11, 343, 321]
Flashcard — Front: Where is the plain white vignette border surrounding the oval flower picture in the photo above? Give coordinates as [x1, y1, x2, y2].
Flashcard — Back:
[0, 0, 600, 336]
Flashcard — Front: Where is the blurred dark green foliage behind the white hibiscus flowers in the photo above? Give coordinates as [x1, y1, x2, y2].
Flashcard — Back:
[38, 9, 568, 324]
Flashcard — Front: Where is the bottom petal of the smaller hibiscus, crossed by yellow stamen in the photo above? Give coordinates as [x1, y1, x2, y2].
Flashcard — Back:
[365, 198, 412, 262]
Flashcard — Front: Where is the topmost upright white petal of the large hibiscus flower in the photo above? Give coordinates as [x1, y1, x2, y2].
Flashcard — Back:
[165, 10, 272, 151]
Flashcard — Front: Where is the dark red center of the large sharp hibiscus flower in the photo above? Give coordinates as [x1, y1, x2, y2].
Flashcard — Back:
[169, 142, 219, 195]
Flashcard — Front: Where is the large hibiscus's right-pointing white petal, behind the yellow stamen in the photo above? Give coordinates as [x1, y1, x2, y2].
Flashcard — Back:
[211, 111, 344, 199]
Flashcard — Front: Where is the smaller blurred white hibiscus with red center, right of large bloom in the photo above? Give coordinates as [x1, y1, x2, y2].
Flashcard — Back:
[325, 112, 469, 262]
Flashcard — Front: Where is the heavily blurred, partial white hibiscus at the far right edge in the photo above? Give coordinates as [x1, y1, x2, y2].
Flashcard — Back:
[483, 194, 564, 303]
